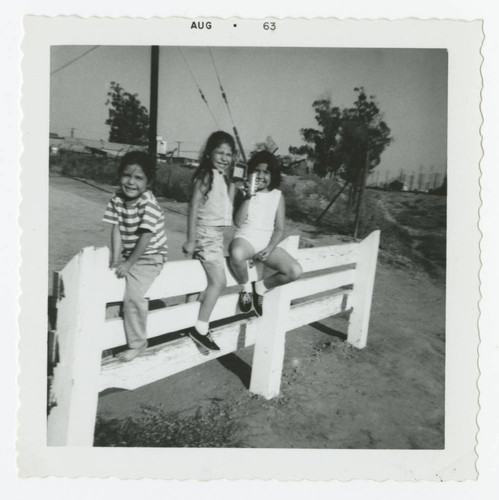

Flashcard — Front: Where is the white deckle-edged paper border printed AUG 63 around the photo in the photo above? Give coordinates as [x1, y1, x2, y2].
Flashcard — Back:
[18, 16, 483, 481]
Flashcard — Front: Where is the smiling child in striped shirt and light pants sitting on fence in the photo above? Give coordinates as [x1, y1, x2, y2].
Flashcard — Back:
[103, 151, 167, 361]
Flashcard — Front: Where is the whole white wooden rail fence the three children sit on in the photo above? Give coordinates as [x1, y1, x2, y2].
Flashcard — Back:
[47, 231, 379, 446]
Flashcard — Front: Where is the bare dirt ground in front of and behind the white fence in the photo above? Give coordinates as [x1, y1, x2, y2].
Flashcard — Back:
[49, 175, 445, 449]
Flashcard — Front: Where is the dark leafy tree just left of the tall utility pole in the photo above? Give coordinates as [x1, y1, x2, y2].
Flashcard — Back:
[106, 82, 149, 146]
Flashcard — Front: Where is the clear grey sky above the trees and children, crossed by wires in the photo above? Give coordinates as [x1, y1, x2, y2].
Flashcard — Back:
[50, 46, 447, 178]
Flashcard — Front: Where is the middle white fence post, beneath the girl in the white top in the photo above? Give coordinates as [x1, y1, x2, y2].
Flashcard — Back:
[250, 236, 299, 399]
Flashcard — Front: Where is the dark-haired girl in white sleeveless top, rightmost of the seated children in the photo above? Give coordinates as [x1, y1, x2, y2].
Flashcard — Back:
[229, 151, 302, 315]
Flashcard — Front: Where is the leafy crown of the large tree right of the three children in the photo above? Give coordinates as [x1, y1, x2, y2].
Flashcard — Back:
[289, 87, 393, 184]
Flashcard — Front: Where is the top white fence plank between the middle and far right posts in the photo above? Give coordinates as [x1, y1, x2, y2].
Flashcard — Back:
[297, 243, 359, 273]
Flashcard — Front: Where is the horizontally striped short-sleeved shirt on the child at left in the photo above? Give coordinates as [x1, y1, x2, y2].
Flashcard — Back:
[102, 191, 167, 257]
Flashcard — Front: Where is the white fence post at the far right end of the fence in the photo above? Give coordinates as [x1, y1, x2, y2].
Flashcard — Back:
[347, 231, 380, 349]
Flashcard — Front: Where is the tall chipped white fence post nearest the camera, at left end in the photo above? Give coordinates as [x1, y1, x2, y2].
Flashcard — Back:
[47, 247, 109, 446]
